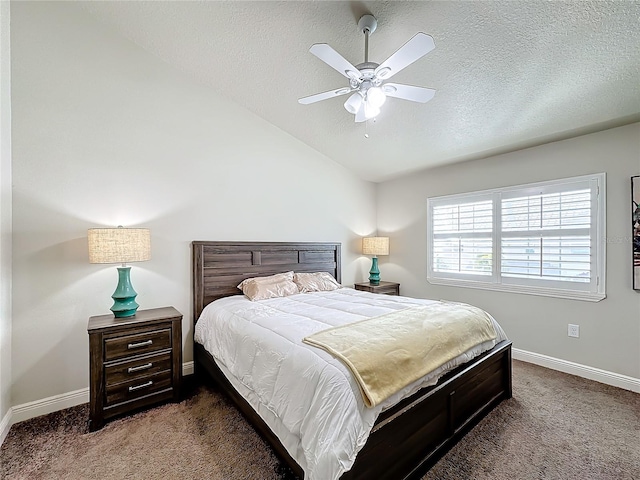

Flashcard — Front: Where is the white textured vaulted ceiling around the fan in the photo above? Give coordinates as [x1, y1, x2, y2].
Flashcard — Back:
[79, 0, 640, 182]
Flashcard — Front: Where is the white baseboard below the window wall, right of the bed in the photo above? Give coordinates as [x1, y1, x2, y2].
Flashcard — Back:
[511, 348, 640, 393]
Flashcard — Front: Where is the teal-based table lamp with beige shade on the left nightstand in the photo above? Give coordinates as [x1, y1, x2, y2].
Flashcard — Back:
[88, 227, 151, 318]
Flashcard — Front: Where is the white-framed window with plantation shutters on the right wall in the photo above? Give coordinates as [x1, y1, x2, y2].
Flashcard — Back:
[427, 173, 605, 301]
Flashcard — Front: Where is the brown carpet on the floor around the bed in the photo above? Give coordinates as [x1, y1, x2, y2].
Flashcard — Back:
[0, 361, 640, 480]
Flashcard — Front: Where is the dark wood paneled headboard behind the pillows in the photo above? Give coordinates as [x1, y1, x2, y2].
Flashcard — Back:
[191, 242, 341, 323]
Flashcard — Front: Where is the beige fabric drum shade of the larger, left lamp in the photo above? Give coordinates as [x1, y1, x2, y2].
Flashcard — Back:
[88, 227, 151, 264]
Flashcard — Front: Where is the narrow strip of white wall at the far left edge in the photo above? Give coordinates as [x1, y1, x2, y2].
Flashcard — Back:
[0, 2, 11, 428]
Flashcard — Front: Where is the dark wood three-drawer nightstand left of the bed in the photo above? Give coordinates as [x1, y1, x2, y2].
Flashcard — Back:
[87, 307, 182, 431]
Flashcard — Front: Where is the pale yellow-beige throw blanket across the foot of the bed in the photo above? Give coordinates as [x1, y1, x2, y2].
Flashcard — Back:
[303, 302, 496, 407]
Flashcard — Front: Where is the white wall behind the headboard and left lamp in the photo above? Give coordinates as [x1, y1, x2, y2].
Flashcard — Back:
[11, 2, 375, 405]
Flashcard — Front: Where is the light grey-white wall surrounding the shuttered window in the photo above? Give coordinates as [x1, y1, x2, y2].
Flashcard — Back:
[377, 123, 640, 379]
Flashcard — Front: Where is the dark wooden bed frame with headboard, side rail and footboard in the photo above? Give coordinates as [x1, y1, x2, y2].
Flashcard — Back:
[192, 242, 511, 480]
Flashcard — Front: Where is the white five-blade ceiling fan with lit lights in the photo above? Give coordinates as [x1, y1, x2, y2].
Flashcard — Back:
[298, 15, 436, 122]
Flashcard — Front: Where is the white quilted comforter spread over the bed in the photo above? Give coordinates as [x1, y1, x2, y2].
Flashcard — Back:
[195, 288, 506, 480]
